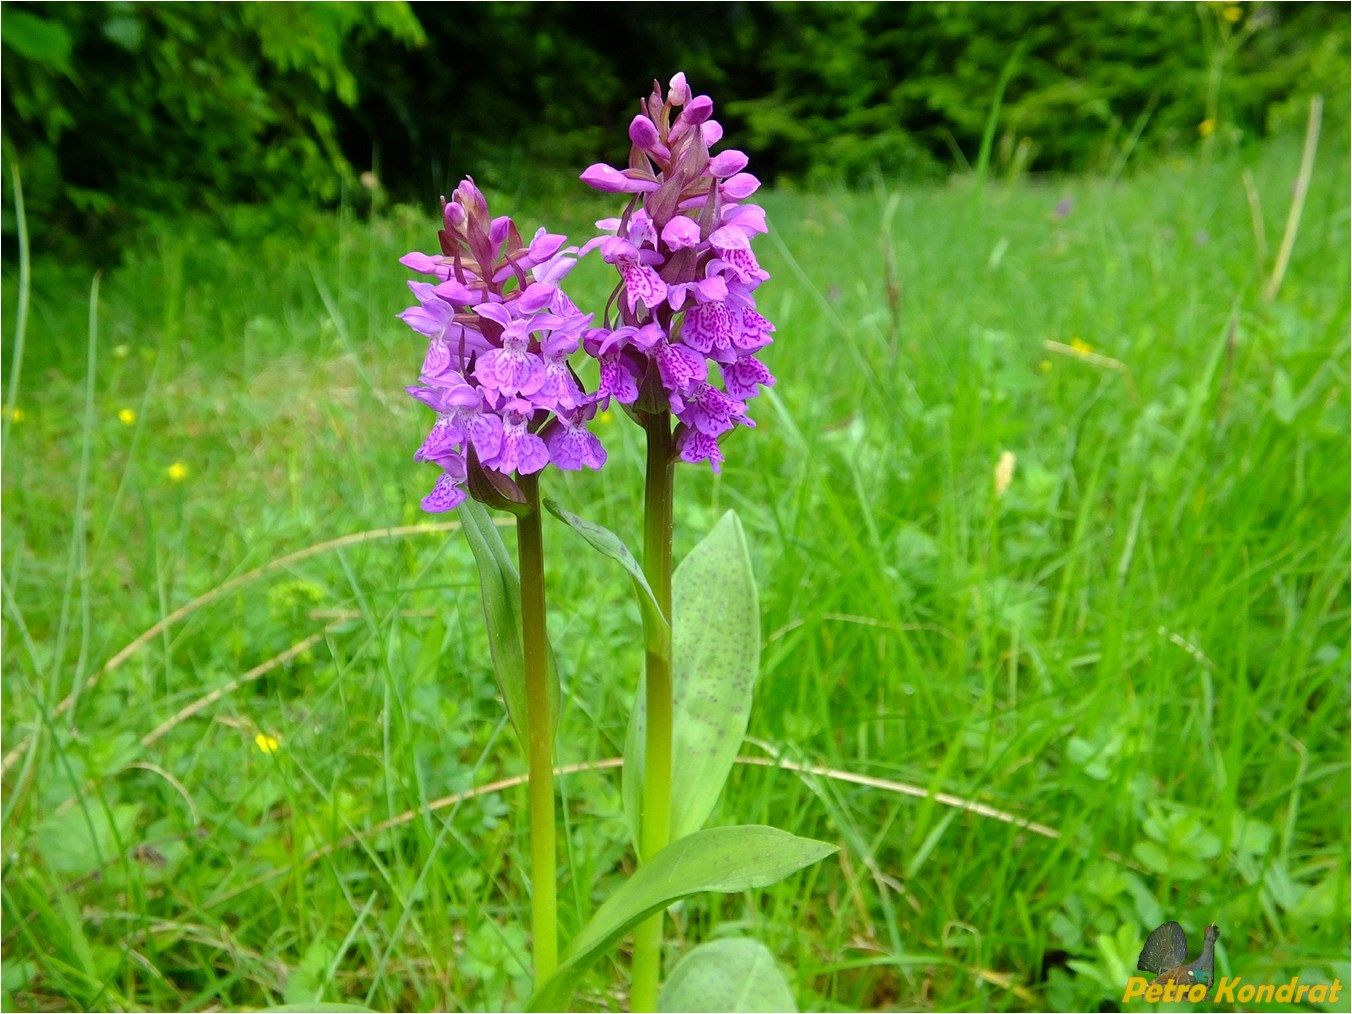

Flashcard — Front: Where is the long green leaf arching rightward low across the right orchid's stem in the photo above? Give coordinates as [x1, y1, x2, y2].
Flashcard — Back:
[526, 825, 836, 1011]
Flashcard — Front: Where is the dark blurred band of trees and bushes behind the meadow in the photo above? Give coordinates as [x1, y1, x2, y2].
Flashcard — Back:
[0, 1, 1348, 251]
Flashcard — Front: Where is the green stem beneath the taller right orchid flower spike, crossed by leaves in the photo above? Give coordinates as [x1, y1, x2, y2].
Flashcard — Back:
[630, 412, 675, 1011]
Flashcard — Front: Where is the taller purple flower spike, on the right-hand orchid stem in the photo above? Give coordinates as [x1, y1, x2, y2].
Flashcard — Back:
[581, 74, 775, 472]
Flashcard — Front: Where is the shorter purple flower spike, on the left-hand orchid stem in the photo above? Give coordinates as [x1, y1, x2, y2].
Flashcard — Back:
[400, 180, 606, 514]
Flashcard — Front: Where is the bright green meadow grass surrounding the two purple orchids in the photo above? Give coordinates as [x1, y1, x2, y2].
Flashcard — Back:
[3, 137, 1349, 1010]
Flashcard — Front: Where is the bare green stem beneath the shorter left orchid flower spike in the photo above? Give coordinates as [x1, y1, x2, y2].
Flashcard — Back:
[516, 476, 558, 988]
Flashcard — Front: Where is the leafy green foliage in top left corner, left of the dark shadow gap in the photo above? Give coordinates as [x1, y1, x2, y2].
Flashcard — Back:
[0, 3, 422, 244]
